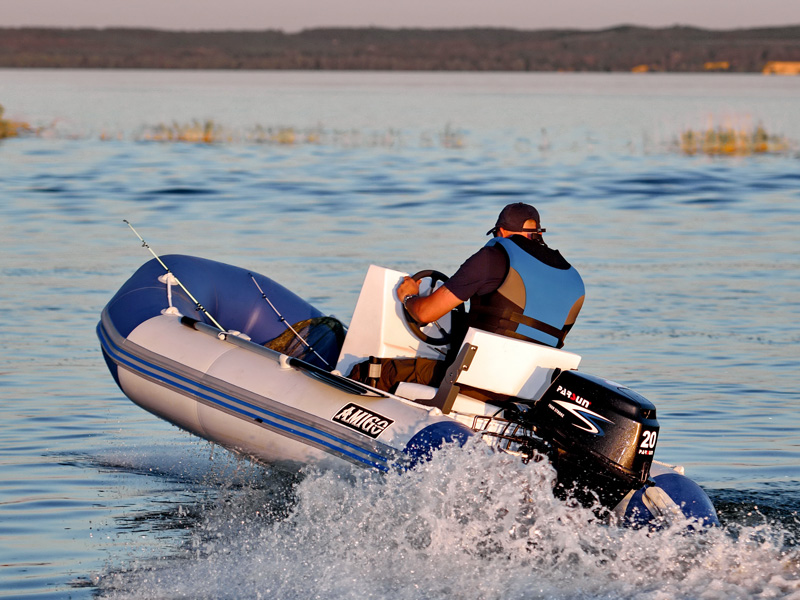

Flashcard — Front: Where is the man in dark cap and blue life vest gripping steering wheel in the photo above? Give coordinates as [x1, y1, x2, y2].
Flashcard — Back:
[397, 202, 585, 351]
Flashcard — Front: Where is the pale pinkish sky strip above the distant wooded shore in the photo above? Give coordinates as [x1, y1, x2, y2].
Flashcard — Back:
[0, 0, 800, 32]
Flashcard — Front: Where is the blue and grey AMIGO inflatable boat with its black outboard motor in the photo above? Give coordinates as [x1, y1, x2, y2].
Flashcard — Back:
[97, 255, 717, 526]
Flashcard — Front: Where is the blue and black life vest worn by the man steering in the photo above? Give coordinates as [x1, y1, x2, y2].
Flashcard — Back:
[469, 237, 585, 348]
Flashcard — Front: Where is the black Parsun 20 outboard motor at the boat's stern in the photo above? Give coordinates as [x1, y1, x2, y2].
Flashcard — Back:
[525, 371, 659, 509]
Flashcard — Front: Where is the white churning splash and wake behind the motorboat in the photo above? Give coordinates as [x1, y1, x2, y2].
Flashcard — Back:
[96, 444, 800, 600]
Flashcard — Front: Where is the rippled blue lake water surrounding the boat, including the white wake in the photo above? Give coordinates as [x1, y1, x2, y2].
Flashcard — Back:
[0, 71, 800, 600]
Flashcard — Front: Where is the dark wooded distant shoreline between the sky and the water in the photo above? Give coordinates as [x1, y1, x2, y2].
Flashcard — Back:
[0, 25, 800, 73]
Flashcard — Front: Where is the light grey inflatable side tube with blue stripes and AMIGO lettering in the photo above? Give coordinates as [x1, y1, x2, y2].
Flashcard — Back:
[98, 302, 472, 471]
